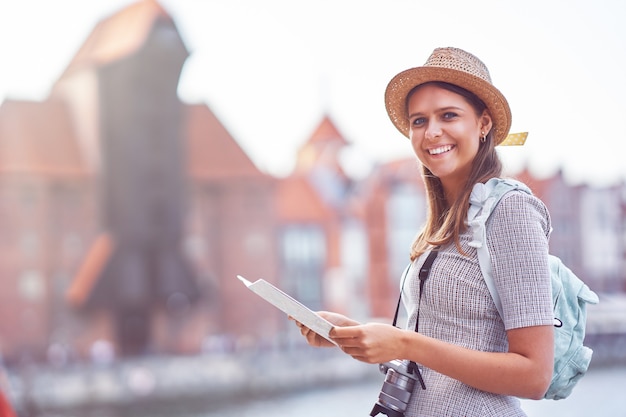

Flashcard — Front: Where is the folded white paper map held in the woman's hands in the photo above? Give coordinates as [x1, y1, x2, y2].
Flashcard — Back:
[237, 275, 336, 344]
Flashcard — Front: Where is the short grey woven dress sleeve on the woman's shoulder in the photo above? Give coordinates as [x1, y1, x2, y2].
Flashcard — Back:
[487, 192, 554, 330]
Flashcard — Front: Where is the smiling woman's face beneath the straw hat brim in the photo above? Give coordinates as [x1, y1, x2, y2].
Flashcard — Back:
[407, 84, 492, 190]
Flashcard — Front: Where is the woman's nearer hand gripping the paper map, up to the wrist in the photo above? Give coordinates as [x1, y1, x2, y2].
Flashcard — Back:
[330, 323, 403, 363]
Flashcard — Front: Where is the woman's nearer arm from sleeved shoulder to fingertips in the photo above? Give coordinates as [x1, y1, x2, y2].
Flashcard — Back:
[331, 194, 554, 398]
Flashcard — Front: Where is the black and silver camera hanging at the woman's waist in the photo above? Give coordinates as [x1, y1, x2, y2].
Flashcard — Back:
[370, 359, 426, 417]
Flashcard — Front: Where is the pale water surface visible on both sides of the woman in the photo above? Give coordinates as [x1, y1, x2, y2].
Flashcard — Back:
[197, 366, 626, 417]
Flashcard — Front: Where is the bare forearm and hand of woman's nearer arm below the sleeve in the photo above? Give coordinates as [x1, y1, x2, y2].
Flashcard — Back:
[331, 324, 554, 399]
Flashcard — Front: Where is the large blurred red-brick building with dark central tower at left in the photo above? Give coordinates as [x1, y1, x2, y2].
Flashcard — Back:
[0, 0, 277, 359]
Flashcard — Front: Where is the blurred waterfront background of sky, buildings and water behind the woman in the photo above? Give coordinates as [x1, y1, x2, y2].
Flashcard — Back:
[0, 0, 626, 417]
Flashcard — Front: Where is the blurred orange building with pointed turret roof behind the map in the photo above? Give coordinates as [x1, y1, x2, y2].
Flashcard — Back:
[276, 115, 369, 317]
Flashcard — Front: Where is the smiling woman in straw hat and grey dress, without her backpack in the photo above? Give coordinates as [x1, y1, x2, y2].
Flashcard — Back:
[298, 48, 554, 417]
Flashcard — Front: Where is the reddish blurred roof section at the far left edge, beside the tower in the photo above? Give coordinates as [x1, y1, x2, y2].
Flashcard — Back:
[0, 100, 88, 177]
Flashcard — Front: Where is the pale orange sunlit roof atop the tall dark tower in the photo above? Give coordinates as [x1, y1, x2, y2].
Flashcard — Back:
[60, 0, 174, 79]
